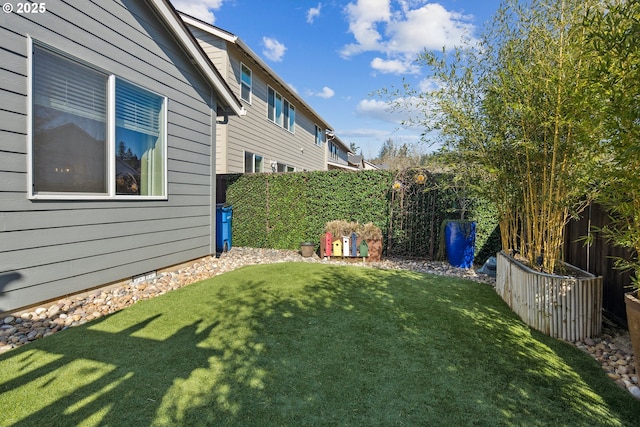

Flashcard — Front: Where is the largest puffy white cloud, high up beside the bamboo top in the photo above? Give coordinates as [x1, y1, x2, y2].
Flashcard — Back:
[341, 0, 475, 73]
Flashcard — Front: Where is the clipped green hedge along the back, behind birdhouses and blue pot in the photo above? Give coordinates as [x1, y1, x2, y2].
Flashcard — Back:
[226, 170, 500, 262]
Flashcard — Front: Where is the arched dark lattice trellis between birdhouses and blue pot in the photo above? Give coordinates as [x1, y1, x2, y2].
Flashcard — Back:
[387, 167, 442, 259]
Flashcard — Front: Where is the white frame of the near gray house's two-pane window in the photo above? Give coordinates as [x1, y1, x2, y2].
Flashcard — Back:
[27, 36, 169, 201]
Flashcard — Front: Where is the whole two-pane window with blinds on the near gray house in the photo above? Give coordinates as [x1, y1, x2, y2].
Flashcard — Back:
[31, 44, 166, 197]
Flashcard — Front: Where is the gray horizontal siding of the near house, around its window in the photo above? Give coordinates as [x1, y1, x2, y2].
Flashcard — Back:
[0, 0, 216, 312]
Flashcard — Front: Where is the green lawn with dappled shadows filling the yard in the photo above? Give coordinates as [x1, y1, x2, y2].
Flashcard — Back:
[0, 263, 640, 426]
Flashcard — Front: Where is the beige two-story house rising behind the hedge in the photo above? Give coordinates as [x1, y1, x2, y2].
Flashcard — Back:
[181, 14, 332, 174]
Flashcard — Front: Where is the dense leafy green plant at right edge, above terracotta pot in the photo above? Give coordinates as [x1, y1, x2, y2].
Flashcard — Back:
[585, 0, 640, 372]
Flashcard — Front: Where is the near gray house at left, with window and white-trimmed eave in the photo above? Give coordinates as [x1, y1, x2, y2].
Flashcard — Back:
[0, 0, 244, 312]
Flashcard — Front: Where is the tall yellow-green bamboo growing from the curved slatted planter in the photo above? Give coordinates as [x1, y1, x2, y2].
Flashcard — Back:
[384, 0, 601, 272]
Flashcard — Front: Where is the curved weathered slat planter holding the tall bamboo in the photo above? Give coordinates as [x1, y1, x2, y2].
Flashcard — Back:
[496, 252, 602, 341]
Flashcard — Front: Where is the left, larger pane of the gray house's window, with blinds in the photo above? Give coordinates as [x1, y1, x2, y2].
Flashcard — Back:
[32, 46, 109, 194]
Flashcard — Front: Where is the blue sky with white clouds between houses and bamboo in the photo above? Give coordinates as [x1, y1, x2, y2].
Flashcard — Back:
[172, 0, 500, 159]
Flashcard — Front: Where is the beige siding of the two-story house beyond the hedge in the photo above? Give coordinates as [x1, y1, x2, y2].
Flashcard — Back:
[189, 26, 327, 173]
